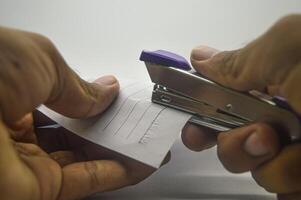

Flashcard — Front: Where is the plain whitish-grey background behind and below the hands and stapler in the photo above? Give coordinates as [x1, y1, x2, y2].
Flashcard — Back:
[0, 0, 301, 200]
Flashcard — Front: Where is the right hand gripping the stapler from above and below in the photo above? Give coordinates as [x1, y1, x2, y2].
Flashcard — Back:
[182, 15, 301, 200]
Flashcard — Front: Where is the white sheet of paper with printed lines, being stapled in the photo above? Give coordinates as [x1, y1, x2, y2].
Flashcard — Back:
[39, 81, 191, 168]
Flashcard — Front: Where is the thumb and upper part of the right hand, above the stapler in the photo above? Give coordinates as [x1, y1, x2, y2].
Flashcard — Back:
[191, 19, 301, 113]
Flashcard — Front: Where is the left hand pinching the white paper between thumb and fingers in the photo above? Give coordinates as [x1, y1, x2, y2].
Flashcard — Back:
[0, 28, 159, 200]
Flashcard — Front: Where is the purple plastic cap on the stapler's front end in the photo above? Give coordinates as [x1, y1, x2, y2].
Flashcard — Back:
[140, 50, 191, 71]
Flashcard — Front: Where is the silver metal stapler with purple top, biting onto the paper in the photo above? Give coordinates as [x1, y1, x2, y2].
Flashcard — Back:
[140, 50, 301, 143]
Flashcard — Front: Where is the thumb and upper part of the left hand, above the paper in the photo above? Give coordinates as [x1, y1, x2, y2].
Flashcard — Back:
[0, 28, 119, 122]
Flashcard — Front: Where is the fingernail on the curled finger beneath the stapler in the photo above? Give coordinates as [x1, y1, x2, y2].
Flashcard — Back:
[244, 132, 270, 156]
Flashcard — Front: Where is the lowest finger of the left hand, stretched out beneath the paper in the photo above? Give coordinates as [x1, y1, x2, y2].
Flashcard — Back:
[58, 160, 148, 199]
